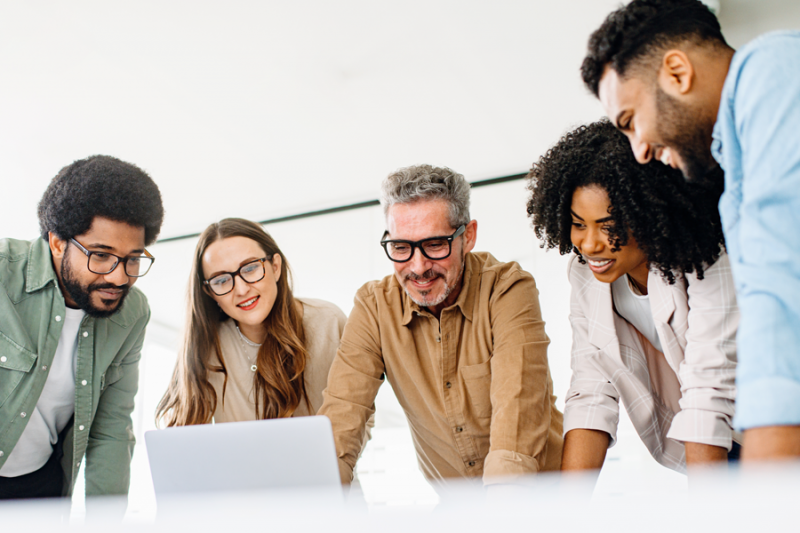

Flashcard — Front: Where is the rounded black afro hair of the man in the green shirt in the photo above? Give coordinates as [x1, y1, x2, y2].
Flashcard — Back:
[38, 155, 164, 246]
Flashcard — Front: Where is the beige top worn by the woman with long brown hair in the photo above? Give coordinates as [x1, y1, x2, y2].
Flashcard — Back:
[208, 298, 347, 422]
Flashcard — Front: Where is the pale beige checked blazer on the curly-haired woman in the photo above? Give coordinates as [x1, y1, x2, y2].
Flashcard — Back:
[564, 254, 739, 472]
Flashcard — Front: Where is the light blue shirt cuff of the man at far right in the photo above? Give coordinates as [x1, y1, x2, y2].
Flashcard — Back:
[733, 377, 800, 430]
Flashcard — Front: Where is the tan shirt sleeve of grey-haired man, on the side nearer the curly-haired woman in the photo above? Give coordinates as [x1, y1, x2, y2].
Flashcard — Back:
[483, 270, 560, 484]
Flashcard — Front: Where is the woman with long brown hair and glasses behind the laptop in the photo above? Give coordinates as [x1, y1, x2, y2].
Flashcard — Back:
[156, 218, 346, 426]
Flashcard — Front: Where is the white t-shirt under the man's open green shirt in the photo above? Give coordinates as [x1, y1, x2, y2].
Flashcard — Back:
[0, 308, 86, 477]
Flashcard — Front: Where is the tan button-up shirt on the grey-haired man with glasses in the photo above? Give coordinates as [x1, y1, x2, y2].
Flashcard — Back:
[319, 252, 563, 483]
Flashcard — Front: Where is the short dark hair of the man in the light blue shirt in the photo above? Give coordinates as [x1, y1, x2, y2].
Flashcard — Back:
[581, 0, 730, 96]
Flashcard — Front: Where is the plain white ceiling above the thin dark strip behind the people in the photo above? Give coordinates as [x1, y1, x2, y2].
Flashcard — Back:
[0, 0, 796, 241]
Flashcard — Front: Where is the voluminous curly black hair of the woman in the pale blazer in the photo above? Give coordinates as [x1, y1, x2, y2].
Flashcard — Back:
[527, 119, 725, 284]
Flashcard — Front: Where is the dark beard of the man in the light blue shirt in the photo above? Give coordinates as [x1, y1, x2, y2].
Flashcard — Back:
[656, 87, 724, 188]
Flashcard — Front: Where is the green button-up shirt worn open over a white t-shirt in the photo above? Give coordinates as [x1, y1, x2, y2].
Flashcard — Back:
[0, 239, 150, 496]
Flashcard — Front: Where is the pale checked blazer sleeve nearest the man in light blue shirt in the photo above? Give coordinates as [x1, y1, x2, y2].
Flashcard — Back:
[667, 254, 739, 450]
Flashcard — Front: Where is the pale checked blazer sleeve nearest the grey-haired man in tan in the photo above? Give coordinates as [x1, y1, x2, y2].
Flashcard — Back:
[564, 259, 619, 447]
